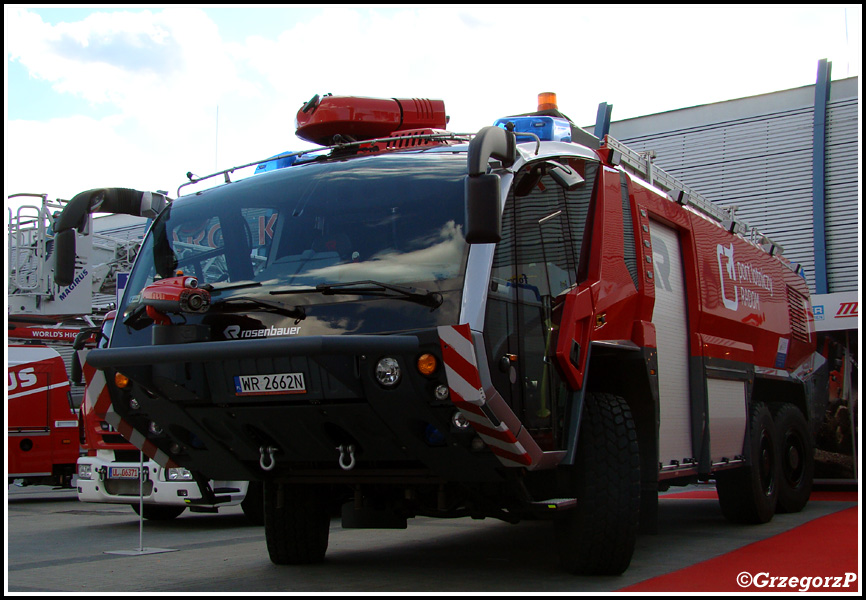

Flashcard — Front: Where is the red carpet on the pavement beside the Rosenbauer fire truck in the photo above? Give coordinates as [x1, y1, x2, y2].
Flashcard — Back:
[618, 490, 860, 594]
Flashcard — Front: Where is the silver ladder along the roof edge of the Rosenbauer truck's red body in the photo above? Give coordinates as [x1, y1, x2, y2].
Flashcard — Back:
[601, 135, 784, 256]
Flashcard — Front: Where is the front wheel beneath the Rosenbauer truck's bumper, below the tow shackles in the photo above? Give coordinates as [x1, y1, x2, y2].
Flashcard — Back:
[264, 481, 331, 565]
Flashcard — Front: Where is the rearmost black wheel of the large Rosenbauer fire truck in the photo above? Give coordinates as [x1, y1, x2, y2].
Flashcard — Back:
[773, 404, 815, 513]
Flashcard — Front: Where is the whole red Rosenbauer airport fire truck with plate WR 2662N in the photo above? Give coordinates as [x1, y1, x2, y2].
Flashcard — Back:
[57, 95, 826, 574]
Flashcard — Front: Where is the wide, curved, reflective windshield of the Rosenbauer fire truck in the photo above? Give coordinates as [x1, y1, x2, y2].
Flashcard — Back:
[121, 152, 468, 336]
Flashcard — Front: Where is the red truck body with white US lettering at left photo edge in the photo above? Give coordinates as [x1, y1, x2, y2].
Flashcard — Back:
[6, 345, 78, 487]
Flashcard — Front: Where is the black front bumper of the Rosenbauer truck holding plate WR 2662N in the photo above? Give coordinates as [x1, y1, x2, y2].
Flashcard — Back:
[87, 330, 502, 482]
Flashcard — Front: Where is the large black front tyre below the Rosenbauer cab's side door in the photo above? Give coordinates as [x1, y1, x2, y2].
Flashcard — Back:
[555, 393, 640, 575]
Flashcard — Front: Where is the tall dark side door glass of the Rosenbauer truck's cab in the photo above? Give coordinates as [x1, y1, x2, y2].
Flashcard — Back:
[485, 160, 596, 449]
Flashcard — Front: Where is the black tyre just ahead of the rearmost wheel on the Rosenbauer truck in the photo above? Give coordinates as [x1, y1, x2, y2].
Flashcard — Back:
[716, 403, 780, 524]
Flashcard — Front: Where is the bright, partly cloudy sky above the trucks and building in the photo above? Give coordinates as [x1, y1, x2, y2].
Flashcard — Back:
[4, 4, 862, 213]
